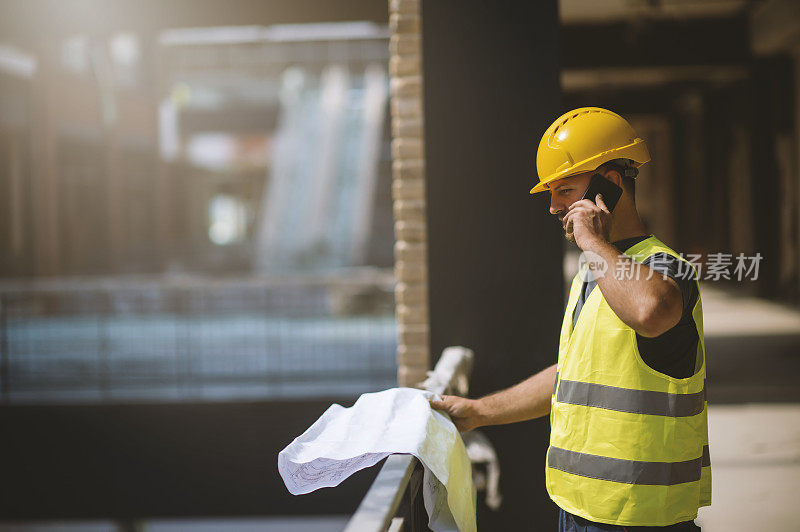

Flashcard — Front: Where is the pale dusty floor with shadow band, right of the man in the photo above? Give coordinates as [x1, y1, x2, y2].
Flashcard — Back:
[697, 286, 800, 532]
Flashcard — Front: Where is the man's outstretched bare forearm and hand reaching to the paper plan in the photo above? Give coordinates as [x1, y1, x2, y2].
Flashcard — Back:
[431, 364, 556, 432]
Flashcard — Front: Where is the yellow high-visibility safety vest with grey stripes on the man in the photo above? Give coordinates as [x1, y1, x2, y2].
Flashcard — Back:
[545, 237, 711, 526]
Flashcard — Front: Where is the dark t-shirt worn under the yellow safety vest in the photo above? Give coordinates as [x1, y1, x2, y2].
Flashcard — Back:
[572, 236, 700, 379]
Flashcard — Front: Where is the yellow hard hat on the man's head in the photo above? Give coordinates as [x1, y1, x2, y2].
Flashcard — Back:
[531, 107, 650, 194]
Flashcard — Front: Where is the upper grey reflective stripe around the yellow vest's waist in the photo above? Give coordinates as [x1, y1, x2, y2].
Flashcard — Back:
[556, 379, 705, 417]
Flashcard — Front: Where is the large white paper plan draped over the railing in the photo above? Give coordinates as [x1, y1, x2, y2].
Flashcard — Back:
[278, 388, 476, 532]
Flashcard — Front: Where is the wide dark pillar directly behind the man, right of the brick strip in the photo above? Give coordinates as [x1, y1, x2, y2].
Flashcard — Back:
[422, 0, 564, 530]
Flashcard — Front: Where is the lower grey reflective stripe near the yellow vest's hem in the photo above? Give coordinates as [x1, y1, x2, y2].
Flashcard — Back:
[547, 446, 702, 486]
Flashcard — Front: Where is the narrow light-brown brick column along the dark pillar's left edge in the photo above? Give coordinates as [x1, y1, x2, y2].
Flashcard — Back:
[389, 0, 430, 386]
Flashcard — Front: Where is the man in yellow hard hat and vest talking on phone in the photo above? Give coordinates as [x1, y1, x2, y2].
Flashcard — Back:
[431, 107, 711, 532]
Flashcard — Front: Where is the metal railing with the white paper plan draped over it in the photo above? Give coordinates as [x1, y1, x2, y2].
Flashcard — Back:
[345, 347, 474, 532]
